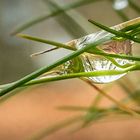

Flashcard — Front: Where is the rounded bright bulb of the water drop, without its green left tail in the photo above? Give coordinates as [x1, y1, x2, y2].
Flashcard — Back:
[73, 31, 132, 83]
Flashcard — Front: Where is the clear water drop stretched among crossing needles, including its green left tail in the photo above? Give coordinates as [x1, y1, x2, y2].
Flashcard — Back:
[40, 19, 139, 83]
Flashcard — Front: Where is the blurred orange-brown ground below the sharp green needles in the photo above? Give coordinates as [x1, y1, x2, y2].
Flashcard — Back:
[0, 80, 140, 140]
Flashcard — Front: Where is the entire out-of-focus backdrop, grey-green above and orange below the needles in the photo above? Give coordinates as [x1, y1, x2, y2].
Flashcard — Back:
[0, 0, 140, 140]
